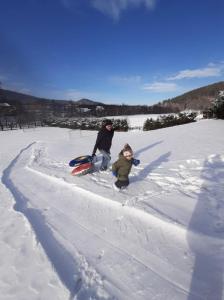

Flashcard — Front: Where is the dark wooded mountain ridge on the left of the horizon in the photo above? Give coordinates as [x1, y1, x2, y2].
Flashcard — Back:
[0, 89, 107, 120]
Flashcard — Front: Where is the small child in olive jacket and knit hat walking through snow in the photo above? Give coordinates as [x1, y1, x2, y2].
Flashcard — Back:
[112, 144, 140, 190]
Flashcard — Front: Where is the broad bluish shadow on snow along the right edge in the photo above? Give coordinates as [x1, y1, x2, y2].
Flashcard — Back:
[188, 155, 224, 300]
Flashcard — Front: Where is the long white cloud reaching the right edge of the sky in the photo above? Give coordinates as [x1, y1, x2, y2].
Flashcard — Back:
[167, 64, 223, 80]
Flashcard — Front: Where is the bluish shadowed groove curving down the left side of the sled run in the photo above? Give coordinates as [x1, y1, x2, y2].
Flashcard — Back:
[2, 143, 114, 300]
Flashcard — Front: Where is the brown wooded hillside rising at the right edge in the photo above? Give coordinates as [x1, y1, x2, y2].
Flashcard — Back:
[162, 81, 224, 111]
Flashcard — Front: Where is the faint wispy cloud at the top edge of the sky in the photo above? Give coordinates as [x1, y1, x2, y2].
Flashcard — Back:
[92, 0, 157, 20]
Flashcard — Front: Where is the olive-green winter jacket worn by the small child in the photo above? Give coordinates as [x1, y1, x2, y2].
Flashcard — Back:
[112, 152, 132, 181]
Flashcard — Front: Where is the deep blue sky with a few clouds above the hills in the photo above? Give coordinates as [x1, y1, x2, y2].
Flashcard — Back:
[0, 0, 224, 105]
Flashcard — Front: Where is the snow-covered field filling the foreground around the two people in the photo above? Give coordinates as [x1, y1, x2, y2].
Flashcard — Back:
[0, 120, 224, 300]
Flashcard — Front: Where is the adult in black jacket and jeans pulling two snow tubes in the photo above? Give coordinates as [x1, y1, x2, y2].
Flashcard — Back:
[92, 119, 114, 171]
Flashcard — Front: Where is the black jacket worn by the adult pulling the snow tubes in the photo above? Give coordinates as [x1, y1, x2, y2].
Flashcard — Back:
[93, 127, 114, 155]
